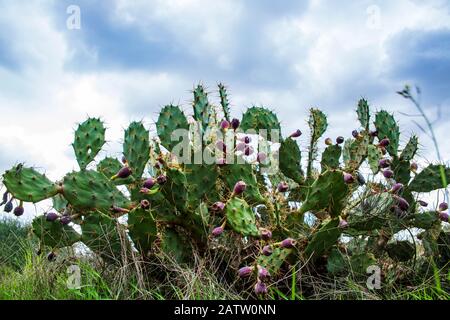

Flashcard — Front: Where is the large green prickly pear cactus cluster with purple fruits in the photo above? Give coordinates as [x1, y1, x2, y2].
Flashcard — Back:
[1, 85, 450, 295]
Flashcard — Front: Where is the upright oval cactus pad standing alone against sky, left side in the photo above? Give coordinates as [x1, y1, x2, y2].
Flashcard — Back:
[72, 118, 106, 169]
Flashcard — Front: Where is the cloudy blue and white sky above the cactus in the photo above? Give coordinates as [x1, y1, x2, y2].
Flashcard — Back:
[0, 0, 450, 219]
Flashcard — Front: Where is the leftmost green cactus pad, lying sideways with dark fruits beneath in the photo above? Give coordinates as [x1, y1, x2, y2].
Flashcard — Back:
[3, 164, 58, 203]
